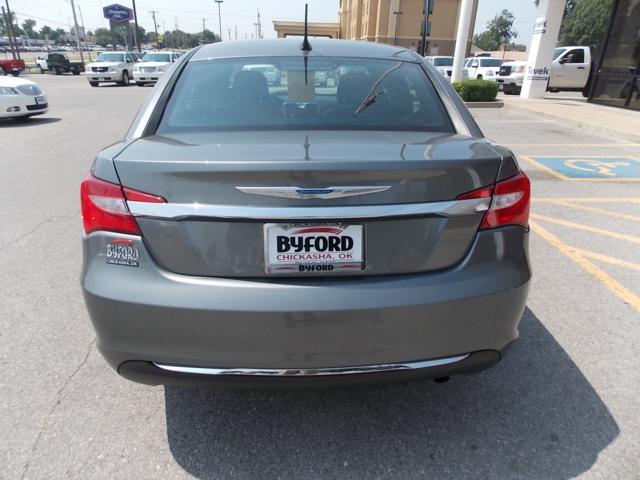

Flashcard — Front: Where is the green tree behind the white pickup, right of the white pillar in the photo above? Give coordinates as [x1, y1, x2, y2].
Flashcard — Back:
[558, 0, 611, 46]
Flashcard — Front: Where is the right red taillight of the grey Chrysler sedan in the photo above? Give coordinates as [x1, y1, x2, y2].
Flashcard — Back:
[458, 171, 531, 230]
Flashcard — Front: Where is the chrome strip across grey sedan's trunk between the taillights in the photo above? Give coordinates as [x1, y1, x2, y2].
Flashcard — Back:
[127, 198, 491, 220]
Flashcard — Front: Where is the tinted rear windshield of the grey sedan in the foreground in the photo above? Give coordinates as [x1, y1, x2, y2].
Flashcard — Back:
[158, 57, 454, 134]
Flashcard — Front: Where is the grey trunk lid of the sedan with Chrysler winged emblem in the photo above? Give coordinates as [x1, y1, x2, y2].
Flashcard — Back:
[115, 131, 500, 277]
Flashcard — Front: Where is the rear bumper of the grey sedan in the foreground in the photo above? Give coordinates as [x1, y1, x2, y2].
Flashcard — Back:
[82, 227, 531, 384]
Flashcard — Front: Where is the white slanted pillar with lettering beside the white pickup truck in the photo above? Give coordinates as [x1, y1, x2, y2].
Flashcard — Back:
[520, 0, 566, 98]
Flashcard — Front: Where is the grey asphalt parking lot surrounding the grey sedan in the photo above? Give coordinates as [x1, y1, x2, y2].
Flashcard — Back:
[0, 75, 640, 479]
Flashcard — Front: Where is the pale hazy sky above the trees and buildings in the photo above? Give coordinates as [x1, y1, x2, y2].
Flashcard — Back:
[8, 0, 537, 44]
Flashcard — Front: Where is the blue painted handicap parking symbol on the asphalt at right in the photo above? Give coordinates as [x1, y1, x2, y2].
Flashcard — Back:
[528, 156, 640, 181]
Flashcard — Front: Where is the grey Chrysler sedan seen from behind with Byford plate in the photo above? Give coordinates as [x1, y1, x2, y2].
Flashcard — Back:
[81, 38, 531, 387]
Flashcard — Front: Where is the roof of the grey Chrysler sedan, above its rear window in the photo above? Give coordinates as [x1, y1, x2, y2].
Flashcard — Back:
[190, 37, 421, 62]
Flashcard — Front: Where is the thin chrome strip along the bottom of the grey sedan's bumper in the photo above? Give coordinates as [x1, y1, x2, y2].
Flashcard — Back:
[154, 353, 469, 377]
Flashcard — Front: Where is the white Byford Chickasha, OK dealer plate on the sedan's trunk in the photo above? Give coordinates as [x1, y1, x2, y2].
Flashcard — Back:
[264, 223, 364, 273]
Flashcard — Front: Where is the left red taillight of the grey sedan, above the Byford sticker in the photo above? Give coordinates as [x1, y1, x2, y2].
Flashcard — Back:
[80, 177, 165, 235]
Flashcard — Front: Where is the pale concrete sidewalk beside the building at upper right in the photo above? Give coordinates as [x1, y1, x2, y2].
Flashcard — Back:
[500, 94, 640, 142]
